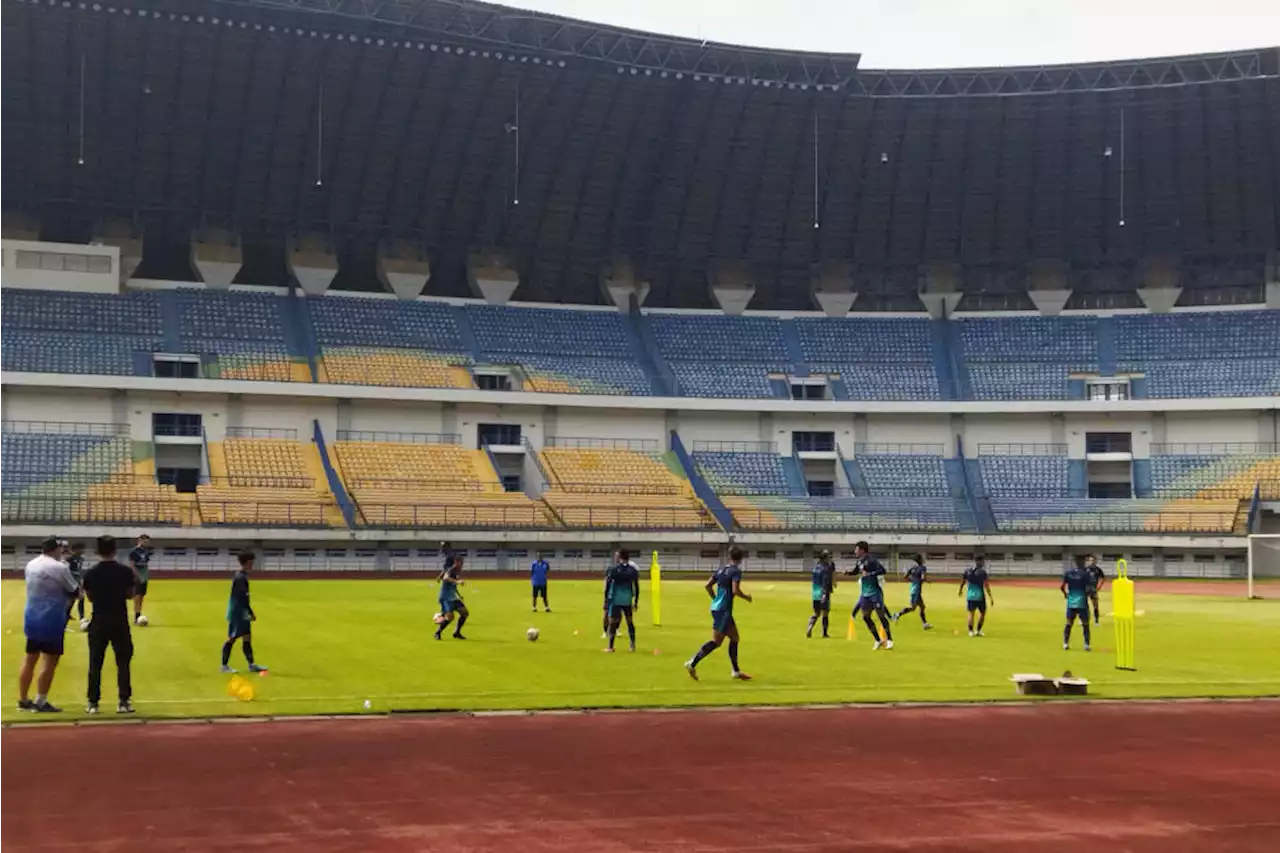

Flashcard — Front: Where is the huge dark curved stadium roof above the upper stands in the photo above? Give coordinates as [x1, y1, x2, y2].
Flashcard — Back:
[0, 0, 1280, 309]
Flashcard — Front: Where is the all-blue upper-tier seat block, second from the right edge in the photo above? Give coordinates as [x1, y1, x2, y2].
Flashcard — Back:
[955, 316, 1098, 400]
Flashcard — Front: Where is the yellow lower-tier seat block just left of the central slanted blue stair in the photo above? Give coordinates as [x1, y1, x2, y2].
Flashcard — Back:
[539, 438, 716, 530]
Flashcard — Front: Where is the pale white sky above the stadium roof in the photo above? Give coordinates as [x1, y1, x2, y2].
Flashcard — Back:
[506, 0, 1280, 68]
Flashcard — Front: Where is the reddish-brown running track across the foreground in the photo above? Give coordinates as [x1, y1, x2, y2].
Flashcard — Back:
[0, 702, 1280, 853]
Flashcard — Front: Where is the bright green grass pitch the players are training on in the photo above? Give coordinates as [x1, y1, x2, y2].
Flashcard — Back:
[0, 578, 1280, 721]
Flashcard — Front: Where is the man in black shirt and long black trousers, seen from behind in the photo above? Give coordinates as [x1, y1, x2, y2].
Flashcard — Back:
[84, 537, 137, 713]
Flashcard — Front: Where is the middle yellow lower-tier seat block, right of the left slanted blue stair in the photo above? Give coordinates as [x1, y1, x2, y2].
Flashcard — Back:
[333, 432, 556, 529]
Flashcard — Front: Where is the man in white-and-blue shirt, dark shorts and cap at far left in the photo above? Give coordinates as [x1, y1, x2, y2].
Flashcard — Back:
[18, 537, 78, 713]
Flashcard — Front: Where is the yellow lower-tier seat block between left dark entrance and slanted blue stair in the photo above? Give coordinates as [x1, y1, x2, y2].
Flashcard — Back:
[196, 428, 346, 528]
